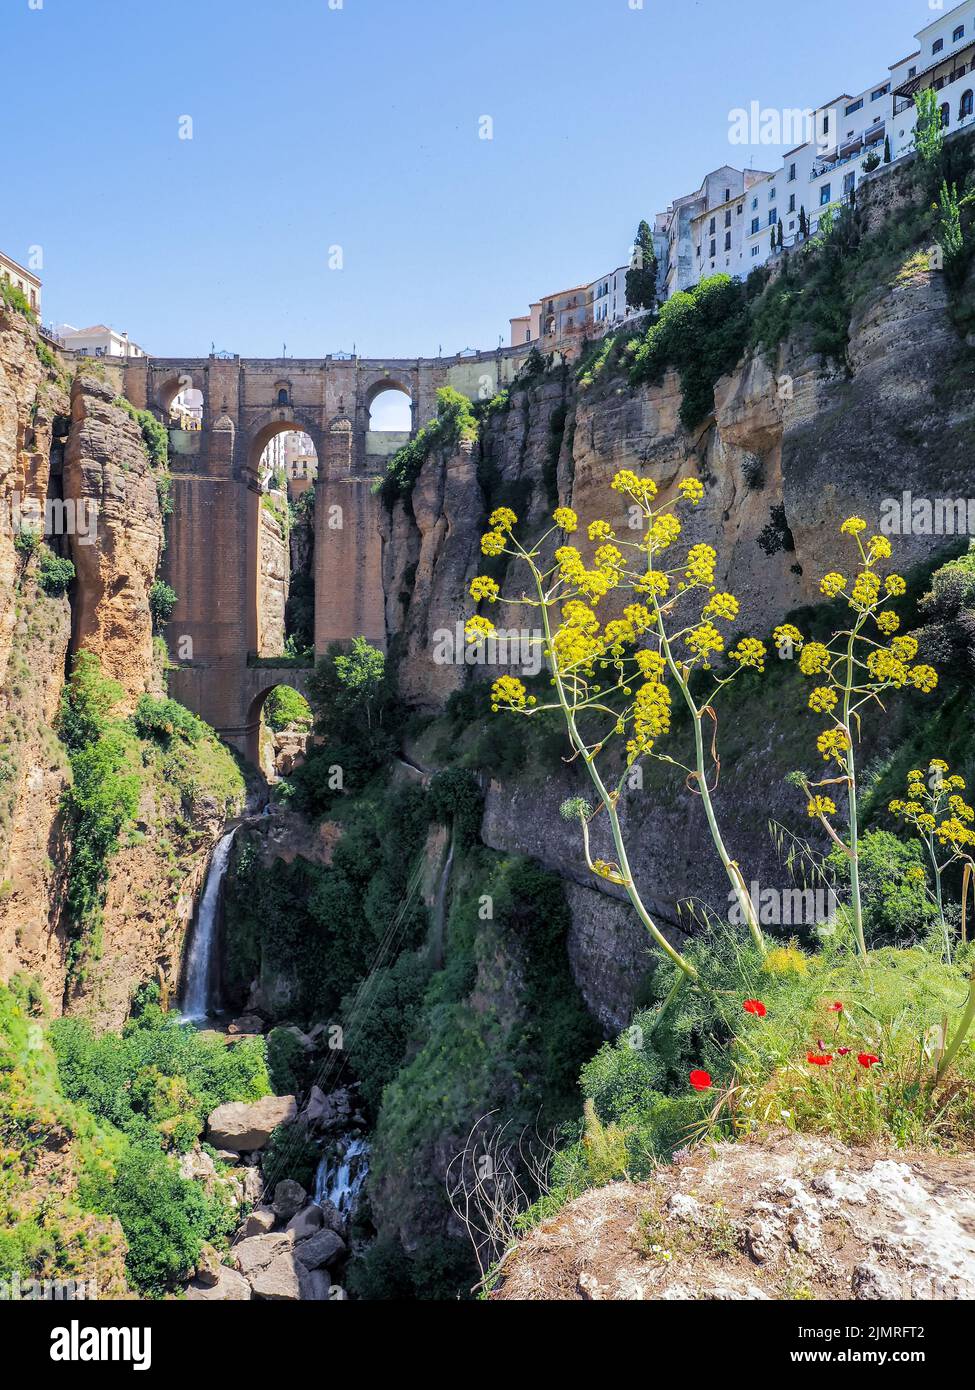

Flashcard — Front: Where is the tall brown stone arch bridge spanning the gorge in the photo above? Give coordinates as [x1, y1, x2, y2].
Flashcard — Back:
[122, 348, 527, 760]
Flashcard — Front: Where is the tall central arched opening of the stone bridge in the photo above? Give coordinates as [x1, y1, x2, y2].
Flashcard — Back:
[250, 421, 319, 660]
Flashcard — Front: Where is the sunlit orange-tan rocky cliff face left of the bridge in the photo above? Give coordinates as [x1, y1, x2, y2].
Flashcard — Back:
[0, 314, 243, 1026]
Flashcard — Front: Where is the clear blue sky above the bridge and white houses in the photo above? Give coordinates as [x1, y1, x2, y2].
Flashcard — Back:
[0, 0, 934, 357]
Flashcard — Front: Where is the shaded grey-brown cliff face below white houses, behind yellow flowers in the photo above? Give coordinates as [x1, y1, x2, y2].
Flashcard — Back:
[384, 258, 975, 1029]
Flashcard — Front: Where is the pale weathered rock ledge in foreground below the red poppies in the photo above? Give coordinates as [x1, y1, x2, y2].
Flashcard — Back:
[492, 1134, 975, 1301]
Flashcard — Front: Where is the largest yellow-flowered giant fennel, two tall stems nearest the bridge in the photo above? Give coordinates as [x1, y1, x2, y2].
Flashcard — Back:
[466, 470, 766, 980]
